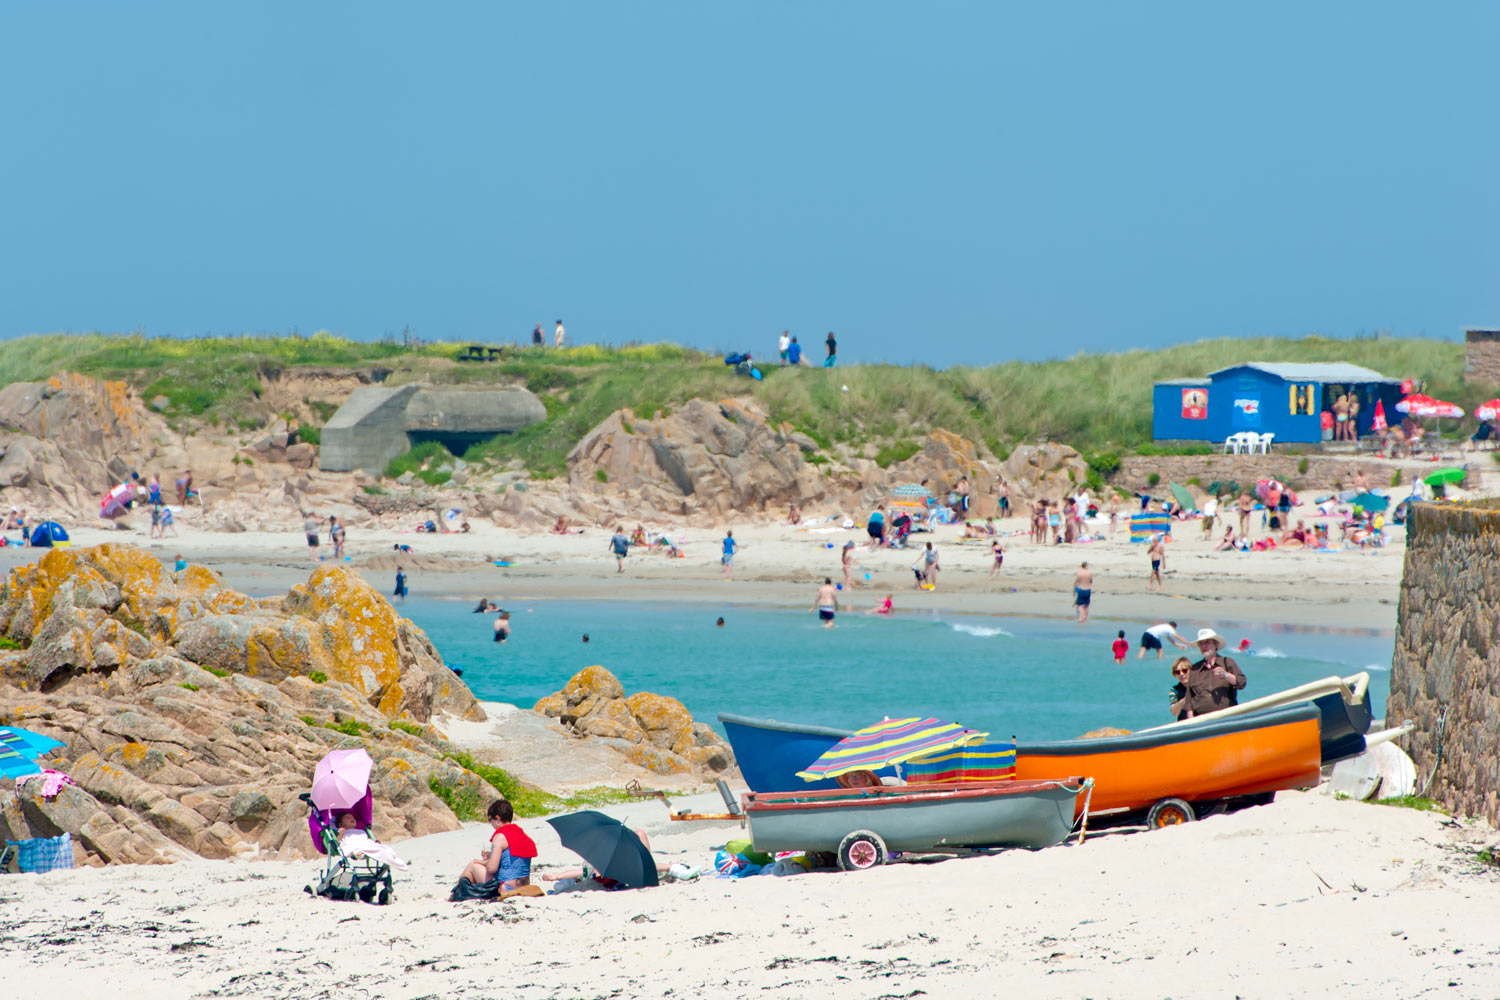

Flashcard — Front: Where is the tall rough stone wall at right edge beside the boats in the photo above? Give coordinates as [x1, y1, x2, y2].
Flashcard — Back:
[1386, 501, 1500, 825]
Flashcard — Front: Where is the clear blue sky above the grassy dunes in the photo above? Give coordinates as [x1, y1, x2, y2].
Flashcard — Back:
[0, 0, 1500, 364]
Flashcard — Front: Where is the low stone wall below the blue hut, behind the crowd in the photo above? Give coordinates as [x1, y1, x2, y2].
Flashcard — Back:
[1110, 453, 1392, 492]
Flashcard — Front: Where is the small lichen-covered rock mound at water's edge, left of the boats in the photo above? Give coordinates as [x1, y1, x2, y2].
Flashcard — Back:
[534, 666, 735, 778]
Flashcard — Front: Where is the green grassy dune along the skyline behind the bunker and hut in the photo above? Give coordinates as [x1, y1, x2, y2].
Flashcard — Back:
[0, 333, 1476, 477]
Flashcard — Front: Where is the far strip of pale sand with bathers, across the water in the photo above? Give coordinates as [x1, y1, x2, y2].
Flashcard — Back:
[0, 494, 1404, 628]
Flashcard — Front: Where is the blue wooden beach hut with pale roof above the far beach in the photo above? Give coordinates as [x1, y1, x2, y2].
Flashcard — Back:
[1151, 361, 1401, 444]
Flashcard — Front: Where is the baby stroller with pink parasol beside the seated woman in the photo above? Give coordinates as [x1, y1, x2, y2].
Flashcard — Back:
[299, 750, 393, 906]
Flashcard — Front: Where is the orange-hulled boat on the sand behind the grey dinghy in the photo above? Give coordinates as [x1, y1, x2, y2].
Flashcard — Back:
[1016, 702, 1323, 826]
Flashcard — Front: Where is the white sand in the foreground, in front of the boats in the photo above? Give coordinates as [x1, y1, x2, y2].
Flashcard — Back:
[0, 761, 1500, 1000]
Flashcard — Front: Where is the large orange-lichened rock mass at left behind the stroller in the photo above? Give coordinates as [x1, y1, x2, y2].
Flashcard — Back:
[0, 546, 494, 862]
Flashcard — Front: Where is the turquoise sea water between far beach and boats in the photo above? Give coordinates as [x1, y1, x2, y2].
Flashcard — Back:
[399, 598, 1394, 741]
